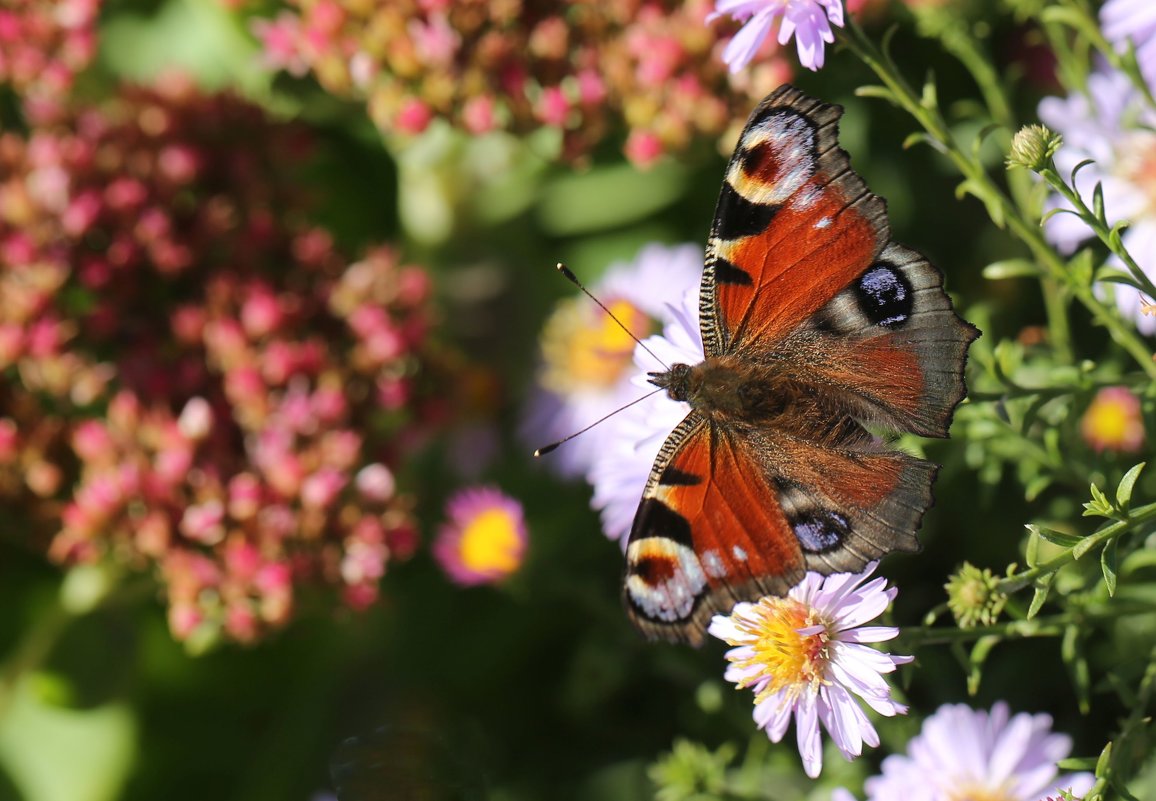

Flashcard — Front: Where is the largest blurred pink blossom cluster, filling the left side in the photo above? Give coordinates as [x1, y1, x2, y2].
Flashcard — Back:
[0, 80, 430, 641]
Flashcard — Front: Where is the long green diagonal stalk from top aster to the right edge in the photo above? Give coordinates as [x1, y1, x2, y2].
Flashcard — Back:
[840, 18, 1156, 379]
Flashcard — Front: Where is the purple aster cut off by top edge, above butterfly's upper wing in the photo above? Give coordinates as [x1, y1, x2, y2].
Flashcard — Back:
[706, 0, 843, 73]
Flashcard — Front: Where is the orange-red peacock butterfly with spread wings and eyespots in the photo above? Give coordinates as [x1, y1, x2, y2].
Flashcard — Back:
[623, 86, 979, 645]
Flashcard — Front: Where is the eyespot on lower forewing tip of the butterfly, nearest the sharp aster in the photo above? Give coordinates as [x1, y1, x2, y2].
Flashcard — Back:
[627, 536, 706, 623]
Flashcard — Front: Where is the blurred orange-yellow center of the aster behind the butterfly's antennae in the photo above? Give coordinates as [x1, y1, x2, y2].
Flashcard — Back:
[542, 298, 653, 394]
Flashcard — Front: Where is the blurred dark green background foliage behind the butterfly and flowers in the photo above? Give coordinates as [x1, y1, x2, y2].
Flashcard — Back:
[0, 0, 1156, 801]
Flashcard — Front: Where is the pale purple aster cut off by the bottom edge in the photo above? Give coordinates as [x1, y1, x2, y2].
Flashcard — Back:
[866, 702, 1095, 801]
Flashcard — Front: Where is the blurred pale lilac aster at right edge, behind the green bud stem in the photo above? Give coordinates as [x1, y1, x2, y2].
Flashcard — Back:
[1039, 72, 1156, 334]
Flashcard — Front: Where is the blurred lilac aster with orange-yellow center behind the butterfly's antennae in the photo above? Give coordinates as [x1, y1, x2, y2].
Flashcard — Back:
[521, 244, 703, 477]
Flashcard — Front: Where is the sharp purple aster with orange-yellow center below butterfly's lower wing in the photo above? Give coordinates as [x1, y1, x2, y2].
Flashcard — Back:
[709, 563, 912, 776]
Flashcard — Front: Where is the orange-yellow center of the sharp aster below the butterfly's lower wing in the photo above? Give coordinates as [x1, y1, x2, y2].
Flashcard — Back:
[734, 598, 830, 704]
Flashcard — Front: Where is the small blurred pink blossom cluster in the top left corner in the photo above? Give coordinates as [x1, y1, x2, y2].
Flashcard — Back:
[0, 0, 102, 119]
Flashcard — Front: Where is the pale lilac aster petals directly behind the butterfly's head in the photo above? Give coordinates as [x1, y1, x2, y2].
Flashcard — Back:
[587, 283, 703, 547]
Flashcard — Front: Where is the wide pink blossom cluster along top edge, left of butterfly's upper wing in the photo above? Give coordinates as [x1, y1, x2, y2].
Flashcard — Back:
[253, 0, 790, 164]
